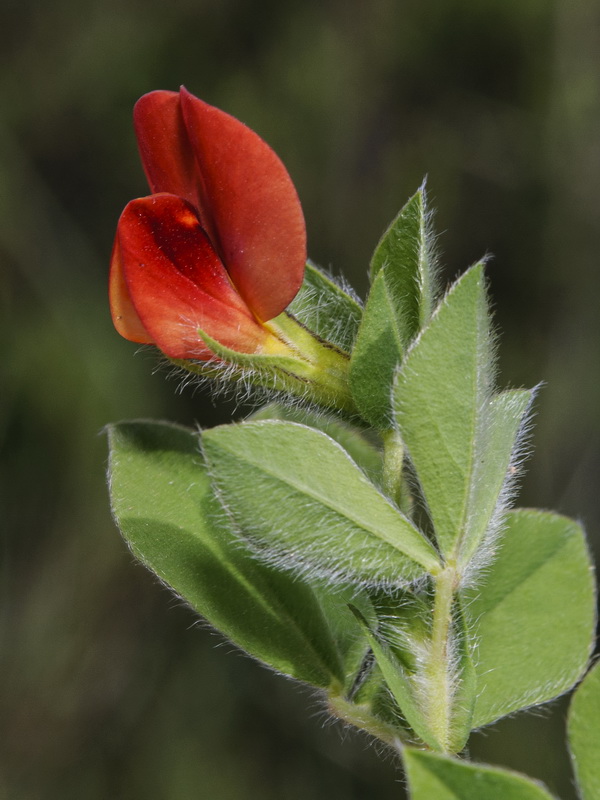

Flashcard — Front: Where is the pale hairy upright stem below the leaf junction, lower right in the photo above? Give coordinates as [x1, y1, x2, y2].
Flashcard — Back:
[425, 565, 457, 752]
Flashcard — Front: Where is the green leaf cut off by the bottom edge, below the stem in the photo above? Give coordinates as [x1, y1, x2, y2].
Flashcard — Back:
[402, 747, 552, 800]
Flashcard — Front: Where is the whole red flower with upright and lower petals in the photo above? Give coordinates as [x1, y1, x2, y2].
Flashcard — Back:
[110, 87, 306, 360]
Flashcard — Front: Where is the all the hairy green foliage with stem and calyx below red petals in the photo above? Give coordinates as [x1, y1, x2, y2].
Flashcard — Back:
[104, 191, 595, 800]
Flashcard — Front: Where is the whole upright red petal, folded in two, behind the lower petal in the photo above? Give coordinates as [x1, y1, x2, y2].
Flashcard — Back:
[134, 88, 306, 320]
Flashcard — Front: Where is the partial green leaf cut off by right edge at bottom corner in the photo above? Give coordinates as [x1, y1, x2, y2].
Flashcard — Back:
[568, 664, 600, 800]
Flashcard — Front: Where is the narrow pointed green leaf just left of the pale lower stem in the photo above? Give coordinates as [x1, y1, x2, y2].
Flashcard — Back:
[351, 606, 441, 750]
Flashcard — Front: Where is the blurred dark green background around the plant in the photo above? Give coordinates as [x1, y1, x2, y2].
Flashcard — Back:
[0, 0, 600, 800]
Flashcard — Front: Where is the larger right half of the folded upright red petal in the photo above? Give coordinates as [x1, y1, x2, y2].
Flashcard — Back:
[178, 87, 306, 320]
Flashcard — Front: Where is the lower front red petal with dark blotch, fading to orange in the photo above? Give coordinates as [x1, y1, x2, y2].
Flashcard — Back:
[115, 194, 268, 359]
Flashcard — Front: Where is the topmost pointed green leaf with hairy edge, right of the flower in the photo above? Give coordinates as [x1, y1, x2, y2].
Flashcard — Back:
[371, 187, 435, 340]
